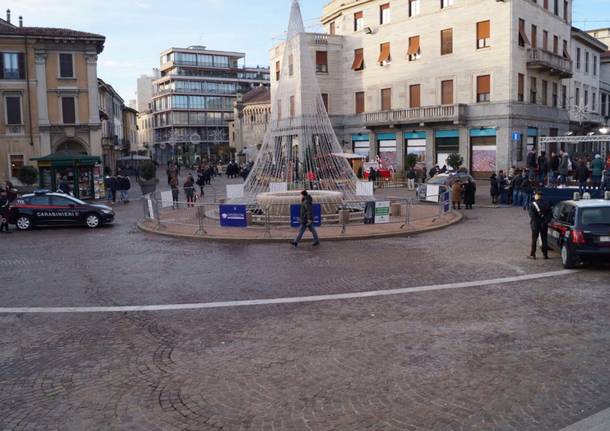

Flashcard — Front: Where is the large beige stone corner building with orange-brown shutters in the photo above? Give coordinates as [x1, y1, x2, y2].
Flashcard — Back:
[270, 0, 572, 176]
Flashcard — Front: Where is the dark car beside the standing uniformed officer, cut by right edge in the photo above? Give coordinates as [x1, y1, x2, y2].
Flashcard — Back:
[549, 199, 610, 269]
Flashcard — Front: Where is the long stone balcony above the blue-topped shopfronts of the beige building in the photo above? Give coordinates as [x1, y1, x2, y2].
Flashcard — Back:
[364, 104, 466, 126]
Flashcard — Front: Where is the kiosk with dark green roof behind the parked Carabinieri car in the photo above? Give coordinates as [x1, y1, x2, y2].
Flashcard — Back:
[33, 154, 104, 199]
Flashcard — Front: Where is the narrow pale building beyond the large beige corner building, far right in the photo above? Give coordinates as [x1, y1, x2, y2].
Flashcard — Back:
[564, 28, 608, 134]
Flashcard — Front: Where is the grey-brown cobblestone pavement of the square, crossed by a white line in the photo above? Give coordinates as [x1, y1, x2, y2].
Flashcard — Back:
[0, 176, 610, 431]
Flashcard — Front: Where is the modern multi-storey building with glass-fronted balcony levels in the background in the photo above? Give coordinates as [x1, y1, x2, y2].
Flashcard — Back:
[152, 46, 269, 163]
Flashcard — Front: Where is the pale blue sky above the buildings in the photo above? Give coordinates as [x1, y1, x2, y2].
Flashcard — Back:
[0, 0, 610, 103]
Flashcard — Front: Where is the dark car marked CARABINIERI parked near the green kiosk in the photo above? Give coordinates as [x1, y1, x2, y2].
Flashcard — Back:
[10, 191, 114, 230]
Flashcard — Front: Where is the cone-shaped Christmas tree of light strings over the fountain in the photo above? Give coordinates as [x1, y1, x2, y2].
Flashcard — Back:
[244, 0, 357, 199]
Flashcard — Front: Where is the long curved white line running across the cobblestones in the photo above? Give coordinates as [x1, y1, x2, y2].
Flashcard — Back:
[0, 270, 580, 314]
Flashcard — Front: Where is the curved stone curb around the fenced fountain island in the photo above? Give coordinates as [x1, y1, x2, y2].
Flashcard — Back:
[136, 211, 464, 244]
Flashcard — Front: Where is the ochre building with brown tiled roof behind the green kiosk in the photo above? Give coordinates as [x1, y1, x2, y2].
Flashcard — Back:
[0, 12, 105, 180]
